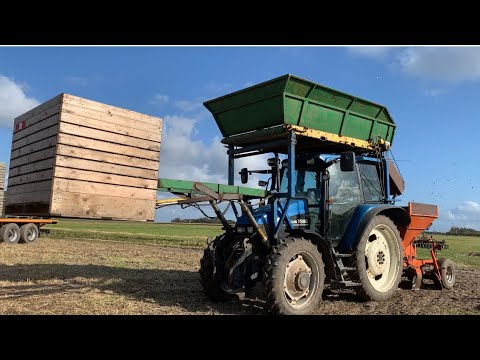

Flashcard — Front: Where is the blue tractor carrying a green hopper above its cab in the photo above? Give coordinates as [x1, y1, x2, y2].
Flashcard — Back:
[160, 75, 448, 314]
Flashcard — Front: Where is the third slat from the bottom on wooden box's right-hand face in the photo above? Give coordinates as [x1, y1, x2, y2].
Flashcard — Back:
[55, 155, 158, 182]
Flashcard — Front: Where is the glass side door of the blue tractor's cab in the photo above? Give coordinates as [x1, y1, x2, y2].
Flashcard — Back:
[327, 162, 362, 243]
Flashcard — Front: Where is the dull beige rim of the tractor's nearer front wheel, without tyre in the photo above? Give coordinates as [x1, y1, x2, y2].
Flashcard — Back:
[283, 252, 318, 310]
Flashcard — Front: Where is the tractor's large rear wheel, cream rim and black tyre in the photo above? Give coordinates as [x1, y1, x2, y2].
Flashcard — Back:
[353, 215, 403, 301]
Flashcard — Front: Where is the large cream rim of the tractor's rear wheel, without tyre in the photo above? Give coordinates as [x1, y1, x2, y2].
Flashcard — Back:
[365, 224, 400, 292]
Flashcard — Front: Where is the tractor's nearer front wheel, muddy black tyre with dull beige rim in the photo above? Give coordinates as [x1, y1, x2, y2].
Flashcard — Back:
[264, 238, 325, 315]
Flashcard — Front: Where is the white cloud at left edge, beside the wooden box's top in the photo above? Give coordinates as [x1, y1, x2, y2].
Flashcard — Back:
[0, 75, 39, 128]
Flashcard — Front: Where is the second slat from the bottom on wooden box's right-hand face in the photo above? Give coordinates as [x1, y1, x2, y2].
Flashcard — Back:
[53, 178, 157, 200]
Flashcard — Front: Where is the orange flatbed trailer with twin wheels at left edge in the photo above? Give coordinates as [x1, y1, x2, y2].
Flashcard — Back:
[0, 216, 58, 245]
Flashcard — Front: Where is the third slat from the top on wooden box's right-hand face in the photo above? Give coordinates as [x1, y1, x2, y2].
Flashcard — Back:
[60, 122, 160, 152]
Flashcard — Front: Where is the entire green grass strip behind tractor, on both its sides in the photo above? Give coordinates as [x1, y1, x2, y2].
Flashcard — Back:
[45, 220, 480, 268]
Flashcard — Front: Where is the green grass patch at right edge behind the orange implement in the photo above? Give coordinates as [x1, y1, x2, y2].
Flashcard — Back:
[418, 235, 480, 268]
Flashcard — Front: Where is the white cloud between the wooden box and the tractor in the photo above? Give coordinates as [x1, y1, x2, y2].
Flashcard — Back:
[156, 115, 268, 221]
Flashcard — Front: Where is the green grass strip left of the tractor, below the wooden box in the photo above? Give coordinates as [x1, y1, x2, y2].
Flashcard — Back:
[45, 219, 223, 247]
